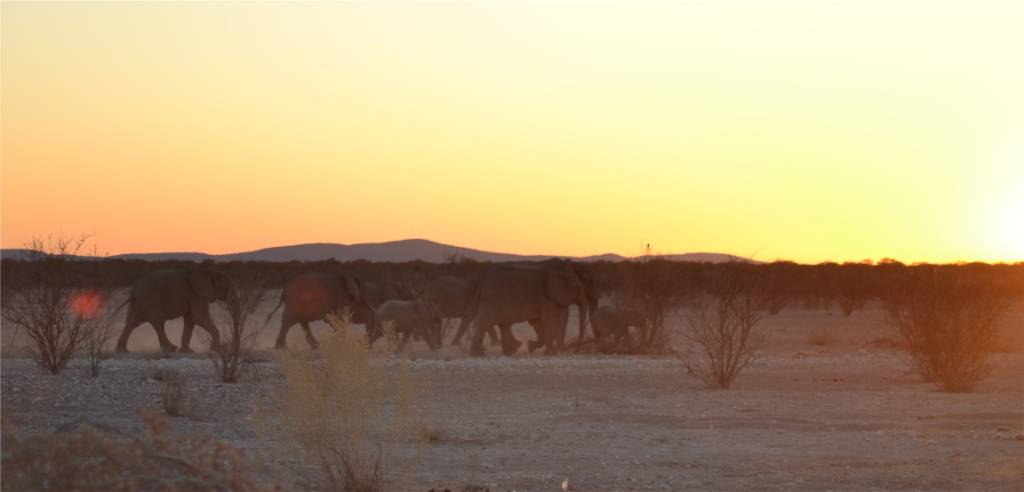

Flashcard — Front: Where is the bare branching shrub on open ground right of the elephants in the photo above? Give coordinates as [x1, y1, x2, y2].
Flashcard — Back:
[678, 263, 766, 390]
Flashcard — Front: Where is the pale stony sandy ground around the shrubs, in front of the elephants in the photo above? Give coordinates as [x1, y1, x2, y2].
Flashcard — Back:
[0, 304, 1024, 491]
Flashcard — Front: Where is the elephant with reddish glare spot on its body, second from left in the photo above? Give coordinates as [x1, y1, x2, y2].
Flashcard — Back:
[266, 273, 376, 349]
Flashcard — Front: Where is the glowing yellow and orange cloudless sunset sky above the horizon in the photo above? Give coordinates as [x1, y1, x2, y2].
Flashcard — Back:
[0, 1, 1024, 262]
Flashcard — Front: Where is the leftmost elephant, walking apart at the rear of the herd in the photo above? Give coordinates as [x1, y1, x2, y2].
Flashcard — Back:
[117, 269, 238, 352]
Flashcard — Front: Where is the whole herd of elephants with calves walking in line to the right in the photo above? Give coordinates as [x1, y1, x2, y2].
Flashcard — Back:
[117, 259, 643, 355]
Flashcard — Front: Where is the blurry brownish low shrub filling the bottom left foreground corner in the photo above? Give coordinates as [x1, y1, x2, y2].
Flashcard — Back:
[2, 415, 274, 492]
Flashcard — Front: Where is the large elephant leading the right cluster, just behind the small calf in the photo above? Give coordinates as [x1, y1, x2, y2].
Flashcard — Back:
[470, 260, 597, 355]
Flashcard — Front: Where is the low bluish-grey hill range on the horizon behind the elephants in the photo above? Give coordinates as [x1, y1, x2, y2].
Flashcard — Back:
[0, 239, 743, 262]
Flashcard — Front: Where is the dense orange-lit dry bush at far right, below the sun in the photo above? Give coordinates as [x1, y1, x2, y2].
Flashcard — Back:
[885, 271, 1010, 392]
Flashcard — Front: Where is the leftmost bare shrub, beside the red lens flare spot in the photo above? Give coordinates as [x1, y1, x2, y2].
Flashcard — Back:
[2, 236, 111, 374]
